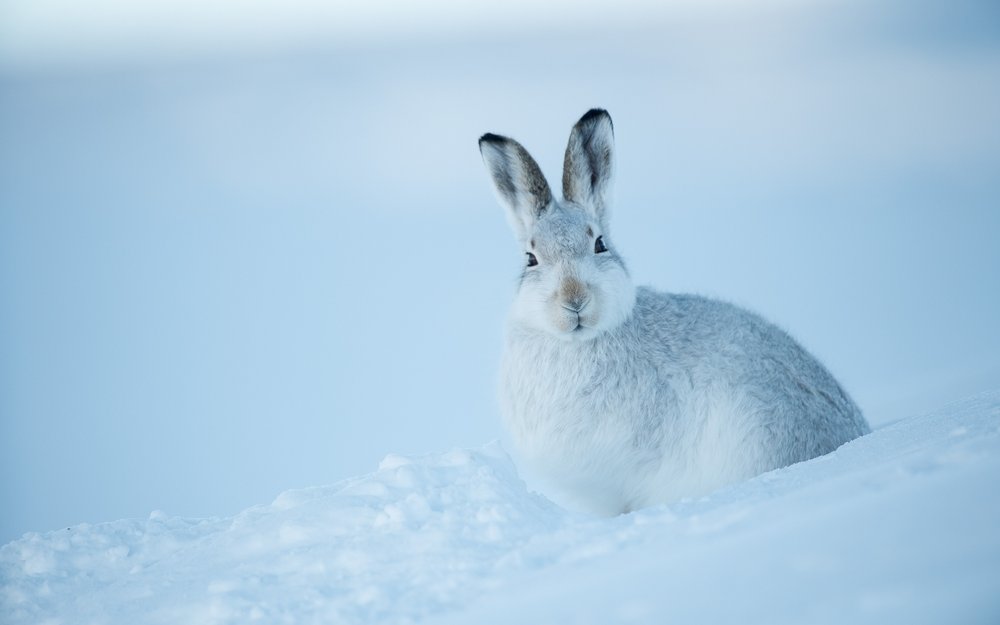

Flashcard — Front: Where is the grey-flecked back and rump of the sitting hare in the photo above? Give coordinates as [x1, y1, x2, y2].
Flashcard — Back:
[634, 288, 869, 464]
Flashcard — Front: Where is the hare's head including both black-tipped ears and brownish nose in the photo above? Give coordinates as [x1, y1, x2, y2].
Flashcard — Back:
[479, 109, 635, 340]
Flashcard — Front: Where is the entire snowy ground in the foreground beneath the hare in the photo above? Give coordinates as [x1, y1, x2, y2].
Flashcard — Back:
[0, 391, 1000, 625]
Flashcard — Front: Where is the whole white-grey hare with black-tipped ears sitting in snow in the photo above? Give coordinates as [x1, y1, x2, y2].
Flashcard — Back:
[479, 109, 869, 514]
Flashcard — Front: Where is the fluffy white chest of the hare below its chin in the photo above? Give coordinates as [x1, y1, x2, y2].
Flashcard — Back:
[500, 336, 660, 514]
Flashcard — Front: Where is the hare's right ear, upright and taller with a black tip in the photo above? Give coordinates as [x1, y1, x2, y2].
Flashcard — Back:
[563, 109, 615, 222]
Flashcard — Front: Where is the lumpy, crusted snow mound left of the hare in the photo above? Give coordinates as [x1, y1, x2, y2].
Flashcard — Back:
[0, 444, 564, 623]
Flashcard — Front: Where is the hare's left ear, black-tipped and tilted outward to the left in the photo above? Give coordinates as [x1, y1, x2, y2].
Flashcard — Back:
[479, 133, 552, 241]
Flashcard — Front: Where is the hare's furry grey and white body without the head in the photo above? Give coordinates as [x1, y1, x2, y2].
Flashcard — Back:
[500, 288, 868, 514]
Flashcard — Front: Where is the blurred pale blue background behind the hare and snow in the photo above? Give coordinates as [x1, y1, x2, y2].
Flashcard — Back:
[0, 0, 1000, 543]
